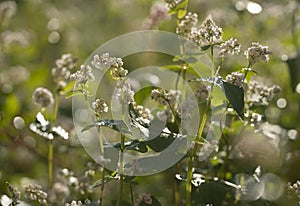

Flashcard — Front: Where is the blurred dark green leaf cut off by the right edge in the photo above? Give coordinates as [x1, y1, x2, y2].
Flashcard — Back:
[286, 54, 300, 92]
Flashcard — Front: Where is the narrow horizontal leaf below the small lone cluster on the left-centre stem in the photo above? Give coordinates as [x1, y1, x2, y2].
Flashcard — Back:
[81, 119, 131, 134]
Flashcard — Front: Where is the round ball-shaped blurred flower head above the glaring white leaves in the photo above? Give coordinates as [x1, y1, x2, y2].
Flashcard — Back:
[32, 87, 54, 108]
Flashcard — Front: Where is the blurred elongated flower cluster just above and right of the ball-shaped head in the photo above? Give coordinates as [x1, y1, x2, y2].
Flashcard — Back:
[51, 54, 77, 89]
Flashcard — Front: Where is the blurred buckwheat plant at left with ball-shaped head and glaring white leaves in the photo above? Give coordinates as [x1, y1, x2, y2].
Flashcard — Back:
[29, 54, 76, 190]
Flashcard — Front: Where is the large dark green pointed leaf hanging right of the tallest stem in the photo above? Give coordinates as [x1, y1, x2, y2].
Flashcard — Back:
[223, 81, 244, 119]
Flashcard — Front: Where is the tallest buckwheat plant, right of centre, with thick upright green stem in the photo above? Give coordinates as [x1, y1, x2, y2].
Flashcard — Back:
[157, 0, 279, 206]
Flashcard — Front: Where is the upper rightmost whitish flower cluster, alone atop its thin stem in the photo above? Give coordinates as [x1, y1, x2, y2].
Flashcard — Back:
[244, 42, 271, 65]
